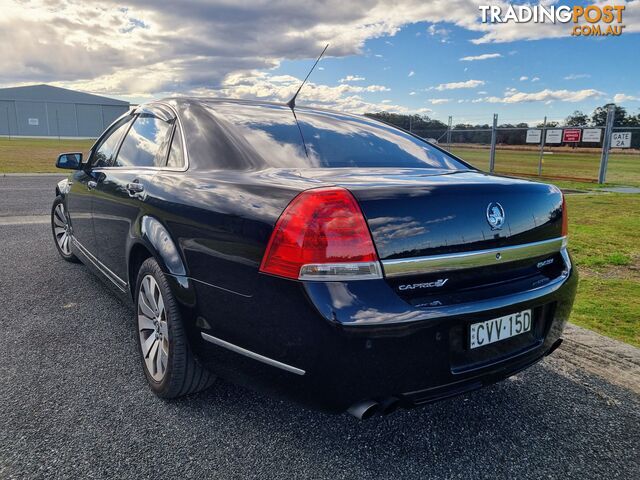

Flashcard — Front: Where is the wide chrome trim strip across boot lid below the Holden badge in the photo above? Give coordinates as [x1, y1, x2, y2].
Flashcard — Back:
[382, 237, 566, 277]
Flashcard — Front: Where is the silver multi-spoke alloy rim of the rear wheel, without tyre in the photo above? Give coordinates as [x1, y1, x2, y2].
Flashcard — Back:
[138, 275, 169, 382]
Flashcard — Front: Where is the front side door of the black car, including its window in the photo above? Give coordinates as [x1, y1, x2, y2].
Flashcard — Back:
[67, 115, 132, 256]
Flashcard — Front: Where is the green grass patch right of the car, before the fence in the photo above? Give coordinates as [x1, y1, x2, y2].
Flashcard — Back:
[567, 194, 640, 347]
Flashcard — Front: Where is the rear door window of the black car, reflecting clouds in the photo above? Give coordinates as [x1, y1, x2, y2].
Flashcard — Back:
[115, 113, 173, 167]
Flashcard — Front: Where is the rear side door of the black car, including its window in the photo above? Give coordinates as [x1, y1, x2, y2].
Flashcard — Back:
[93, 107, 176, 287]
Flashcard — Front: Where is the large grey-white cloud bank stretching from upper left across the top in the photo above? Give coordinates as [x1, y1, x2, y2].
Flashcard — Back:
[0, 0, 640, 98]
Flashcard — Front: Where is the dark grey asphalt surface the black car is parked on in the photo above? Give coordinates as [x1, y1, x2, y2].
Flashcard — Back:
[0, 177, 640, 479]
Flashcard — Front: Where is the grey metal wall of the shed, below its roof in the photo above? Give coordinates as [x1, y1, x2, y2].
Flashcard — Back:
[0, 100, 128, 138]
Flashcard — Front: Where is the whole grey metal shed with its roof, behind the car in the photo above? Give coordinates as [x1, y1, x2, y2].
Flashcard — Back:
[0, 85, 129, 138]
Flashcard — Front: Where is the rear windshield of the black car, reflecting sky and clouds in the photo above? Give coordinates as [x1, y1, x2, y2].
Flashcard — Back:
[200, 103, 469, 170]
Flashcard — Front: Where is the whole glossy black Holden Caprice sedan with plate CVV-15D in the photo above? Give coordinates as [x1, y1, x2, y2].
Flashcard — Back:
[51, 98, 577, 418]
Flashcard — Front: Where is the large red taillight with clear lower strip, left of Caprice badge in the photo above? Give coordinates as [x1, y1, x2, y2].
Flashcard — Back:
[260, 187, 382, 281]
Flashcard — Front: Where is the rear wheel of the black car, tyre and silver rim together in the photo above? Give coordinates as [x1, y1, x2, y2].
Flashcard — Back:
[135, 258, 216, 398]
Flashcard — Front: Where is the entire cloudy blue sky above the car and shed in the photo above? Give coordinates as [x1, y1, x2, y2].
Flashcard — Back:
[0, 0, 640, 124]
